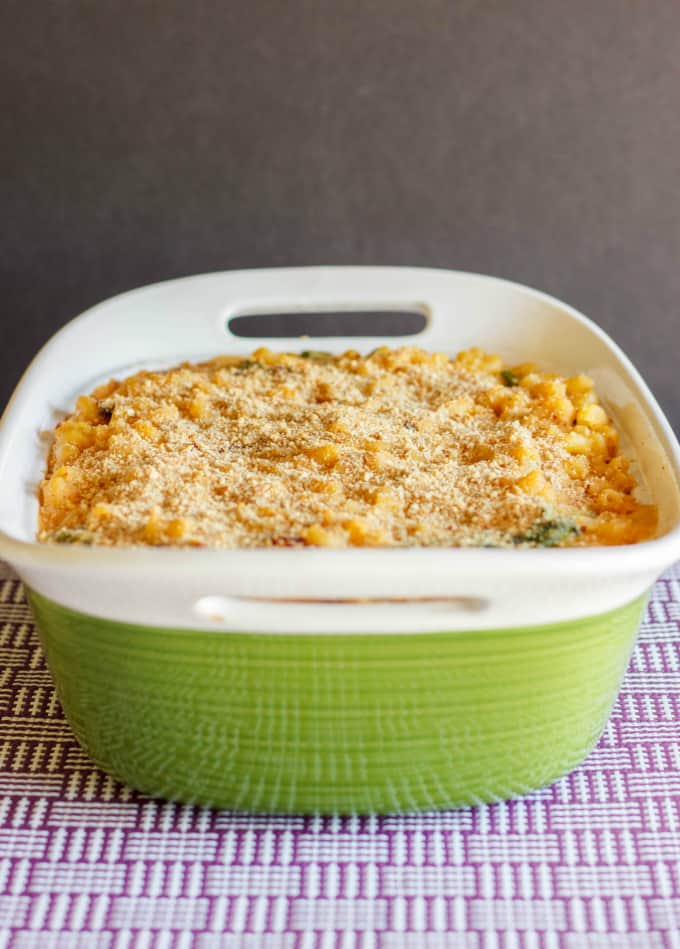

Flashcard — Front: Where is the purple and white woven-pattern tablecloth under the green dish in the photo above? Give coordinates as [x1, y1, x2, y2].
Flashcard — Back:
[0, 565, 680, 949]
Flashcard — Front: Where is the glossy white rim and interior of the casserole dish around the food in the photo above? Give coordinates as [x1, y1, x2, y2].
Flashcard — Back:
[0, 267, 680, 633]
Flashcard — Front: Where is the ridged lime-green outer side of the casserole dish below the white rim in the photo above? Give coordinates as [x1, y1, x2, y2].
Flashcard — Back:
[29, 592, 646, 814]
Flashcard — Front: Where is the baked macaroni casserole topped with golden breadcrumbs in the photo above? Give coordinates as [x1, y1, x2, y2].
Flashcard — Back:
[38, 347, 656, 548]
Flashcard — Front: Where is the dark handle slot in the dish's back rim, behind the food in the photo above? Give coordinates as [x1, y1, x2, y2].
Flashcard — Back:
[227, 307, 427, 339]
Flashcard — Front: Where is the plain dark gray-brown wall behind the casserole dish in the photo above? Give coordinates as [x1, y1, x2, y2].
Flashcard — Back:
[0, 0, 680, 427]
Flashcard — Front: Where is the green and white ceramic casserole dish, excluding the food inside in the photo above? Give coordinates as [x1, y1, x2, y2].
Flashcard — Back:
[0, 267, 680, 813]
